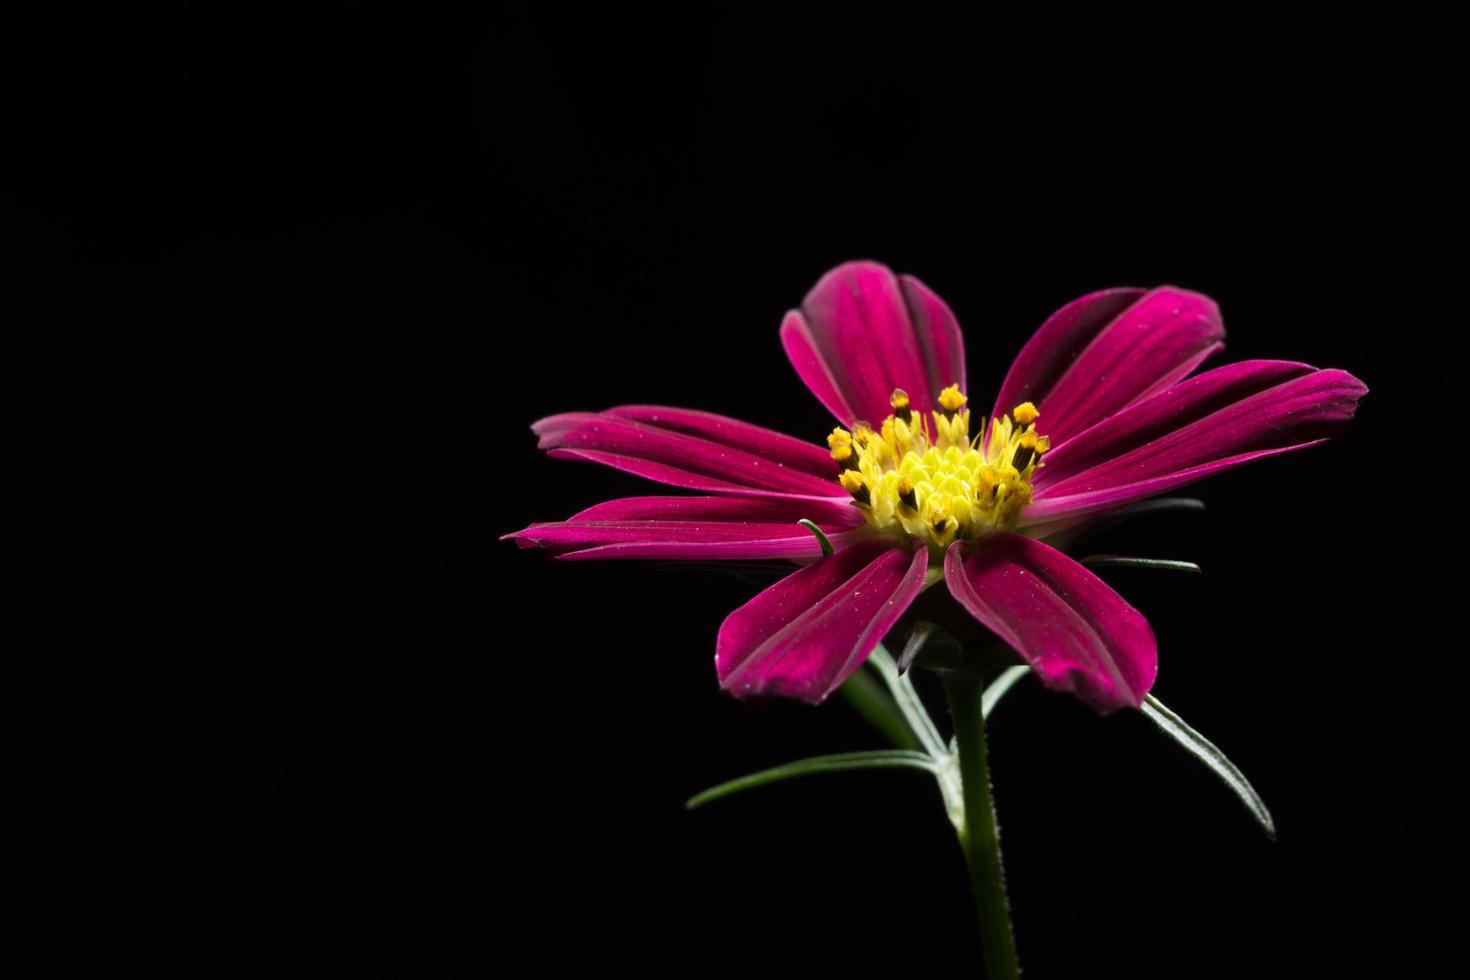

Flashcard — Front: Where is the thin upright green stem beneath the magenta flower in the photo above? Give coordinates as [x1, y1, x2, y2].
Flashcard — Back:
[942, 670, 1020, 980]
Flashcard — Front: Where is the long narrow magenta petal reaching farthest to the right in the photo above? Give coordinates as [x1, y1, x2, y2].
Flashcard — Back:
[1023, 361, 1367, 525]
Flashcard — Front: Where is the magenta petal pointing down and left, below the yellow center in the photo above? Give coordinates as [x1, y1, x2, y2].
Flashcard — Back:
[714, 538, 929, 704]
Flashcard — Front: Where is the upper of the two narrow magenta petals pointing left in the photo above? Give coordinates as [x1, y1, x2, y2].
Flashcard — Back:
[531, 406, 842, 498]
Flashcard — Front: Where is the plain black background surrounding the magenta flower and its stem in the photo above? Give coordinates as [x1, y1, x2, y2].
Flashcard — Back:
[0, 4, 1466, 977]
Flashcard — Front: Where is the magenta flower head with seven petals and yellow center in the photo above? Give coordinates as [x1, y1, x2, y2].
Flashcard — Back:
[507, 262, 1367, 713]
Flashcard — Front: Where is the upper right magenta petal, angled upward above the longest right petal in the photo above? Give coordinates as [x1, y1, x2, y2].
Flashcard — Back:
[995, 287, 1225, 447]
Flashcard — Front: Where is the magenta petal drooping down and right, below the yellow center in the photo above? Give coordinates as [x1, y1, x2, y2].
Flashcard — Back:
[944, 532, 1158, 714]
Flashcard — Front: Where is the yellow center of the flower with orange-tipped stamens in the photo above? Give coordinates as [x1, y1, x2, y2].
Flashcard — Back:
[828, 385, 1050, 560]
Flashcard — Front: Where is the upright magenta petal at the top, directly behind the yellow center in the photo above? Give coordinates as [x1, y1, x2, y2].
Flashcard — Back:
[781, 262, 964, 425]
